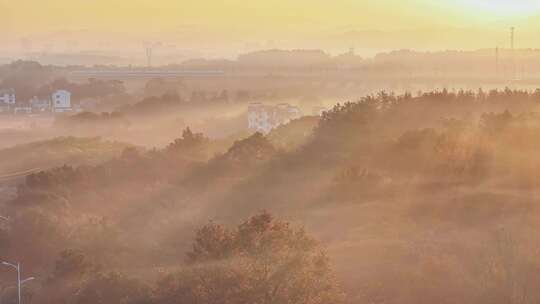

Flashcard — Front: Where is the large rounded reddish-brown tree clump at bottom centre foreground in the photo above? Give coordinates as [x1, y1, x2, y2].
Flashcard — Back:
[156, 212, 343, 304]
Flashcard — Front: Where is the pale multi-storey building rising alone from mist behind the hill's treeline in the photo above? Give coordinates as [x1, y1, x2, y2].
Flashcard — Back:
[248, 103, 302, 134]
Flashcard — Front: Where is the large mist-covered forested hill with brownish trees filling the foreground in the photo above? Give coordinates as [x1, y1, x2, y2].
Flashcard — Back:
[0, 90, 540, 304]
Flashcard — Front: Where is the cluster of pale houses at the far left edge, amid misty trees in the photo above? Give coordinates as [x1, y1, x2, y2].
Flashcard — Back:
[0, 89, 75, 114]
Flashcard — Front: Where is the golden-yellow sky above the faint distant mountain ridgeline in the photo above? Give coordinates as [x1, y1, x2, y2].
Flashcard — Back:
[0, 0, 540, 32]
